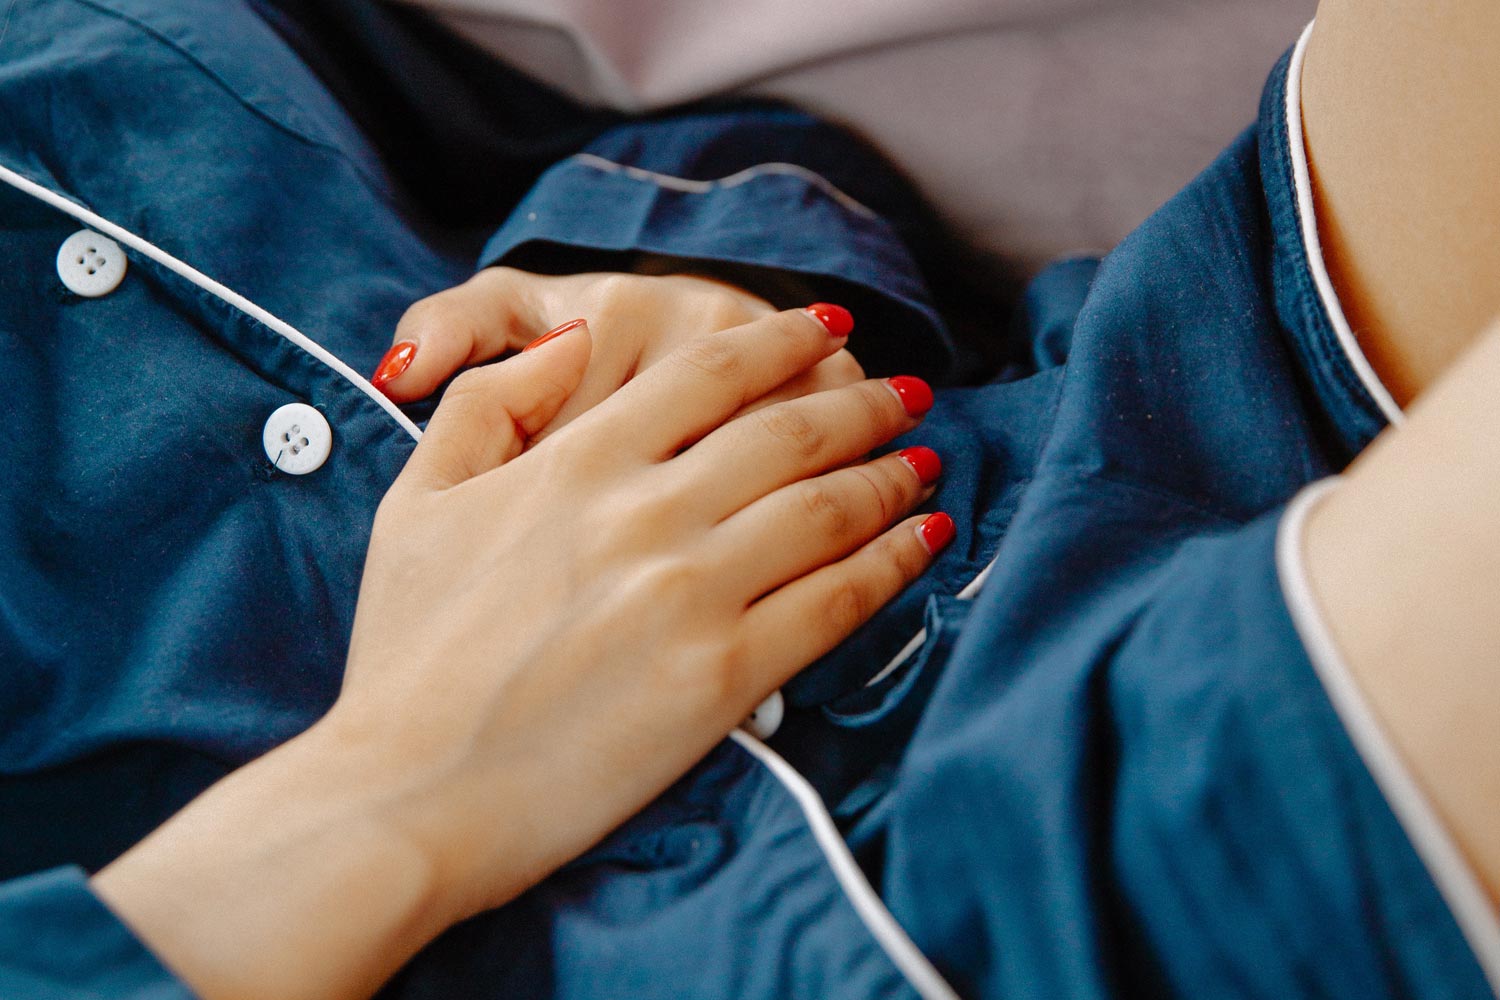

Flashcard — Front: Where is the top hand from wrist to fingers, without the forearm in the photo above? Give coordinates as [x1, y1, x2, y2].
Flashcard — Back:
[348, 310, 930, 909]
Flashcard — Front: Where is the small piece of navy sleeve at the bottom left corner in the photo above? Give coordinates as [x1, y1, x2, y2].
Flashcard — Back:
[0, 867, 194, 1000]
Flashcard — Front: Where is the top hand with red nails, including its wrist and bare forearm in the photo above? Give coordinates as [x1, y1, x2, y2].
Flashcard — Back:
[95, 305, 947, 1000]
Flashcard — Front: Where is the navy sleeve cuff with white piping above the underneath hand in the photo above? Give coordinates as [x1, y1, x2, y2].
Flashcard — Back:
[480, 105, 978, 381]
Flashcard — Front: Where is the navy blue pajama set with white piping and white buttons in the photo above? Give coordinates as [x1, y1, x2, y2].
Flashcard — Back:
[0, 0, 1500, 1000]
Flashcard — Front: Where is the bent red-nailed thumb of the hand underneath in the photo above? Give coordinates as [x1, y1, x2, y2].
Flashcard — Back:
[371, 267, 542, 403]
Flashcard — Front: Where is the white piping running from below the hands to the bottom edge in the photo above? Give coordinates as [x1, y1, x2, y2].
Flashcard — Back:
[729, 729, 959, 1000]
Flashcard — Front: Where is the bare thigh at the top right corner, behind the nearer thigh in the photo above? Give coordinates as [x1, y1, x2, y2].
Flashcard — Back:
[1302, 0, 1500, 403]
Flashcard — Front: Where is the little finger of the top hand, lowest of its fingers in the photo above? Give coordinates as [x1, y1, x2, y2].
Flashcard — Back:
[741, 513, 954, 691]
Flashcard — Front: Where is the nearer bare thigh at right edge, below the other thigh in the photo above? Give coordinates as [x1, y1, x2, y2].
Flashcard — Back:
[1304, 322, 1500, 901]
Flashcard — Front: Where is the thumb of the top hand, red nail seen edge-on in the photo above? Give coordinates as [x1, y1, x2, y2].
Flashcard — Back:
[407, 319, 593, 489]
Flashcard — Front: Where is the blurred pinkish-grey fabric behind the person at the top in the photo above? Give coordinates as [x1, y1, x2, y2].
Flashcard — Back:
[399, 0, 1317, 276]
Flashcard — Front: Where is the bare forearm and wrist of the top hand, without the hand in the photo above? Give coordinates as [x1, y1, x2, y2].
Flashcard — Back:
[93, 726, 453, 1000]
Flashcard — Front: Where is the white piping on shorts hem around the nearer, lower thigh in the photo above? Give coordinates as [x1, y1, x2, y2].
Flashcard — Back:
[1277, 477, 1500, 996]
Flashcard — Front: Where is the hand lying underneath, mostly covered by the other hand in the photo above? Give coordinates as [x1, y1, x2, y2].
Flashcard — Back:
[371, 267, 864, 438]
